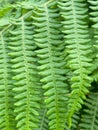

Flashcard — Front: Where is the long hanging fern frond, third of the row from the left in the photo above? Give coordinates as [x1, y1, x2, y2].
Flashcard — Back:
[33, 3, 68, 130]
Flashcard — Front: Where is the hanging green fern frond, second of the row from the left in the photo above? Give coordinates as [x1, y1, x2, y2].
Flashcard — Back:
[9, 17, 40, 130]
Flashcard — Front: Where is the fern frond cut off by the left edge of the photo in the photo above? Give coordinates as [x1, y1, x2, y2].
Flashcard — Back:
[0, 33, 15, 130]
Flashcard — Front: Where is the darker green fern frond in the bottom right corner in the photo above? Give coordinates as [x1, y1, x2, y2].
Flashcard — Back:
[80, 93, 98, 130]
